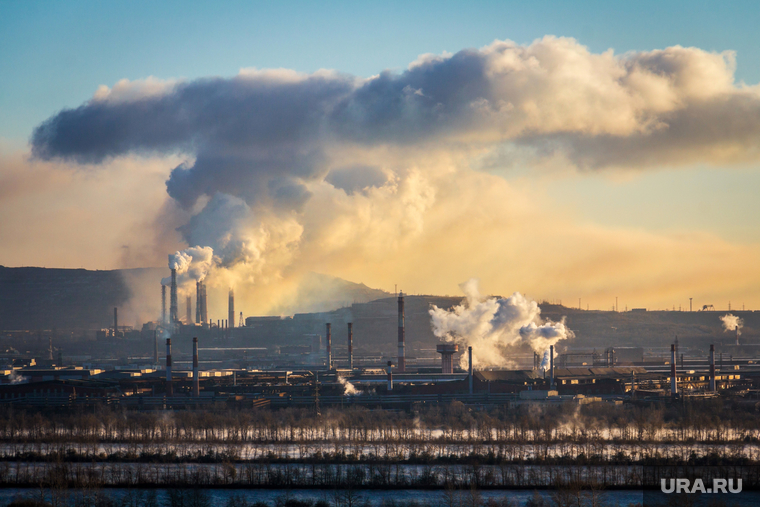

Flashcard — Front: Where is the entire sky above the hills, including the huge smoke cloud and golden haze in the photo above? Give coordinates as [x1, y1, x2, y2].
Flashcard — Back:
[0, 0, 760, 313]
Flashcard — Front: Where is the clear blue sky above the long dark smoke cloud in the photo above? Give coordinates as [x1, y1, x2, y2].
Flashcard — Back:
[0, 0, 760, 142]
